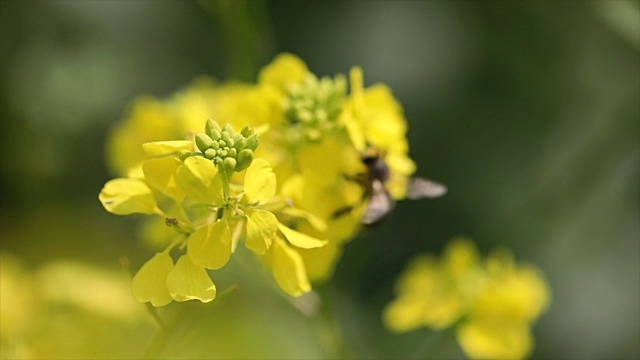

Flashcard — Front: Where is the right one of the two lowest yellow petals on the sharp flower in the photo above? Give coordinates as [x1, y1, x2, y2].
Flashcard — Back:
[167, 256, 216, 303]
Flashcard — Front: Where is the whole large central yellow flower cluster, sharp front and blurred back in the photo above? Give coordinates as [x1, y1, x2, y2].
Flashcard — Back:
[100, 54, 424, 305]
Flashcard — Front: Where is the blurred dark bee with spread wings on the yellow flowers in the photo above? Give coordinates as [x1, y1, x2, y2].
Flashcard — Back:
[333, 148, 447, 226]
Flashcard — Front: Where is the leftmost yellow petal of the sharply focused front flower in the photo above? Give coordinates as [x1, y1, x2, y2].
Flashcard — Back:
[98, 178, 157, 215]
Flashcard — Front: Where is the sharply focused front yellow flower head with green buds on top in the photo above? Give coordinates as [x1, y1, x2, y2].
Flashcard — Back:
[99, 120, 326, 306]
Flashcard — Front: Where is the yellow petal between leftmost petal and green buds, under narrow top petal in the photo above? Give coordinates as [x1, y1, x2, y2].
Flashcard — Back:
[142, 156, 184, 201]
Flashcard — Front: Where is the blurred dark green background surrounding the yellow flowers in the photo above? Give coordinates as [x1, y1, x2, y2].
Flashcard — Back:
[0, 0, 640, 359]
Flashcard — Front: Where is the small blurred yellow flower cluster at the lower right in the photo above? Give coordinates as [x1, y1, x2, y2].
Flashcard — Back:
[383, 239, 550, 359]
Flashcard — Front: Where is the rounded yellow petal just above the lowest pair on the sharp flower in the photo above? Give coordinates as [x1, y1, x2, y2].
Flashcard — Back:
[187, 219, 231, 269]
